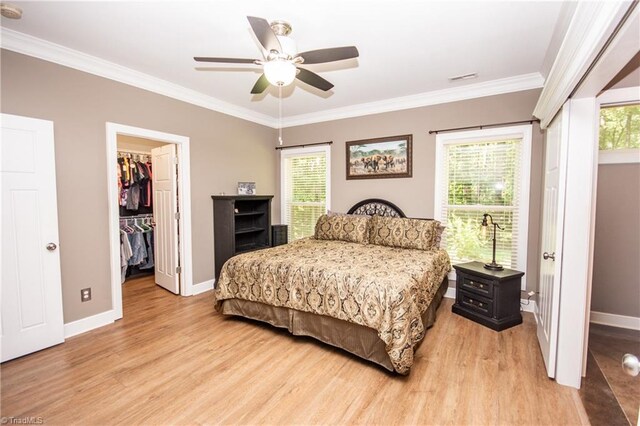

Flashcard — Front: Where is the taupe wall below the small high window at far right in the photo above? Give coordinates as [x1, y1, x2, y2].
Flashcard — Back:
[591, 164, 640, 317]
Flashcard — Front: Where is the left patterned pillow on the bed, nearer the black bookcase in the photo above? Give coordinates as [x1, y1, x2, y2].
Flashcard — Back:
[315, 214, 370, 244]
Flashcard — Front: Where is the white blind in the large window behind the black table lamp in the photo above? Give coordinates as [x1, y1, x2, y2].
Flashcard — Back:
[439, 139, 522, 268]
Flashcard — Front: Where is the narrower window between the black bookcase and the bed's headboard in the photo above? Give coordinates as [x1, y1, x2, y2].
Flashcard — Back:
[280, 145, 331, 241]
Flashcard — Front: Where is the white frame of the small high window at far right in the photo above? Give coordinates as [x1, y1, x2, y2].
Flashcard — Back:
[596, 86, 640, 164]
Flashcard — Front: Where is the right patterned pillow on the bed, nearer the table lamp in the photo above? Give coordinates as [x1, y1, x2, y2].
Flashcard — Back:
[369, 216, 441, 250]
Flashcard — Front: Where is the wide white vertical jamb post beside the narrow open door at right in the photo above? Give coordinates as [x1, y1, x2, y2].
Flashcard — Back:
[555, 97, 599, 389]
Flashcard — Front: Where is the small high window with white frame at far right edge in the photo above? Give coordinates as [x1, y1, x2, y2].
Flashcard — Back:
[598, 87, 640, 164]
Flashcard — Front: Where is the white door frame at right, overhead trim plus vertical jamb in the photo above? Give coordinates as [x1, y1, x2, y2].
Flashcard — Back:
[534, 1, 640, 388]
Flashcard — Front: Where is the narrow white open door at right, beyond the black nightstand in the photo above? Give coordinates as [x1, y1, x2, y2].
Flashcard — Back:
[535, 106, 568, 378]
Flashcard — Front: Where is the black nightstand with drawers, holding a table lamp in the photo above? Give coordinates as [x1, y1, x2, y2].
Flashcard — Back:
[451, 262, 524, 331]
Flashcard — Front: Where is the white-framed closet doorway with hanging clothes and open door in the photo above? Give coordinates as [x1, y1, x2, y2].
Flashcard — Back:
[107, 123, 193, 319]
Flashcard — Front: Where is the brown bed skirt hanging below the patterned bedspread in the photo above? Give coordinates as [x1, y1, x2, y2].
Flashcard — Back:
[222, 276, 449, 371]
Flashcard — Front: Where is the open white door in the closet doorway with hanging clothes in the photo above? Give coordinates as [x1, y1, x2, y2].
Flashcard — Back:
[151, 144, 180, 294]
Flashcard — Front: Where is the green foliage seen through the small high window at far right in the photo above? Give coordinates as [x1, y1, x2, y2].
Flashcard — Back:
[600, 105, 640, 150]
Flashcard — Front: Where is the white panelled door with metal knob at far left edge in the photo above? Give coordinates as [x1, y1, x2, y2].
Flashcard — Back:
[0, 114, 64, 362]
